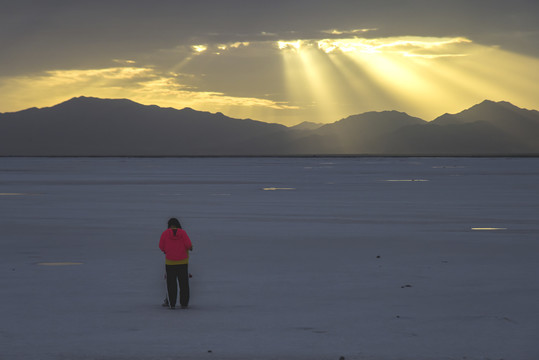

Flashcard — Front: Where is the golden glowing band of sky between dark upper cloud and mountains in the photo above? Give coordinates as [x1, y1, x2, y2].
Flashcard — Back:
[0, 34, 539, 124]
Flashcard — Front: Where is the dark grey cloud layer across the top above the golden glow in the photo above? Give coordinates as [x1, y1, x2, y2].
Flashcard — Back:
[0, 0, 539, 75]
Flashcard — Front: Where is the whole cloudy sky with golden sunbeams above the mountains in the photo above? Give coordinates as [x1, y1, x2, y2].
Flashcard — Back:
[0, 0, 539, 125]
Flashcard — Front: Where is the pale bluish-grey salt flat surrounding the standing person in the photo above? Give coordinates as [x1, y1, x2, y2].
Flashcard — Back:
[0, 158, 539, 360]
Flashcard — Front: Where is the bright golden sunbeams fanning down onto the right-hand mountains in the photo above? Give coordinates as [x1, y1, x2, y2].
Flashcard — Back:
[278, 37, 539, 122]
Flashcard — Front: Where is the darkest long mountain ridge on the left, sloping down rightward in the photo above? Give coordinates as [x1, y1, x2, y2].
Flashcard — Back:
[0, 97, 288, 156]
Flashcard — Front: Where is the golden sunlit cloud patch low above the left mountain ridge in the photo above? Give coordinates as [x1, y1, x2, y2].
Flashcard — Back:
[0, 64, 295, 119]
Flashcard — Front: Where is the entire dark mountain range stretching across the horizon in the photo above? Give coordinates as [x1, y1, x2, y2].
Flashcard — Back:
[0, 97, 539, 156]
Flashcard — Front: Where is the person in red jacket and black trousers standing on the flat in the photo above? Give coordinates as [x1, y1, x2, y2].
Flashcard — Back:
[159, 218, 193, 309]
